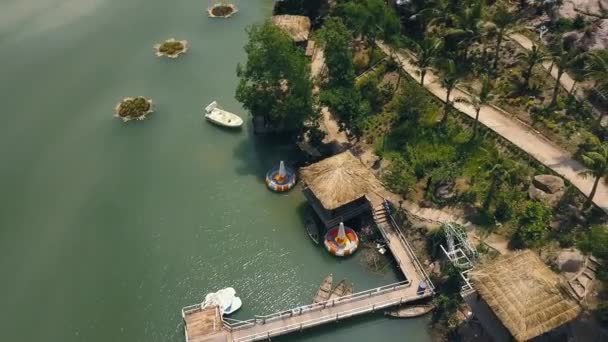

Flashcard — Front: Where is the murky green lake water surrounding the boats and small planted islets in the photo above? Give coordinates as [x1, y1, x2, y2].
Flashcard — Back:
[0, 0, 430, 342]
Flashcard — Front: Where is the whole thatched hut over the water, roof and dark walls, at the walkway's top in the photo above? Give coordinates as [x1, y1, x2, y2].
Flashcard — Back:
[300, 151, 382, 227]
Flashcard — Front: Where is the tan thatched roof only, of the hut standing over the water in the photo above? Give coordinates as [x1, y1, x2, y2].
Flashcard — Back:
[300, 151, 382, 210]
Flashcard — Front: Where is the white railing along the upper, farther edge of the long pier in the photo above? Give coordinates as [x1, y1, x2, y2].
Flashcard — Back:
[224, 280, 414, 330]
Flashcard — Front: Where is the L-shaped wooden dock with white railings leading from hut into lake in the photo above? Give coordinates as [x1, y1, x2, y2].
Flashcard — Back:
[182, 197, 434, 342]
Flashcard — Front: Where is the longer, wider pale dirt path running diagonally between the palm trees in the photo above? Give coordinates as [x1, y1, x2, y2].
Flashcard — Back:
[378, 42, 608, 212]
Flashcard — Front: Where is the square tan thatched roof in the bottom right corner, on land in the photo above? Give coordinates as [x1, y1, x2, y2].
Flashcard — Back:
[470, 250, 581, 341]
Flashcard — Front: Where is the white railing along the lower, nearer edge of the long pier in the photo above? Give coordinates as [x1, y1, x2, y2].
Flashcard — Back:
[233, 291, 432, 342]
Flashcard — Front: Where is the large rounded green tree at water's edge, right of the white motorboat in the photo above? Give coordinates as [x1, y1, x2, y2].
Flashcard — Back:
[236, 21, 317, 133]
